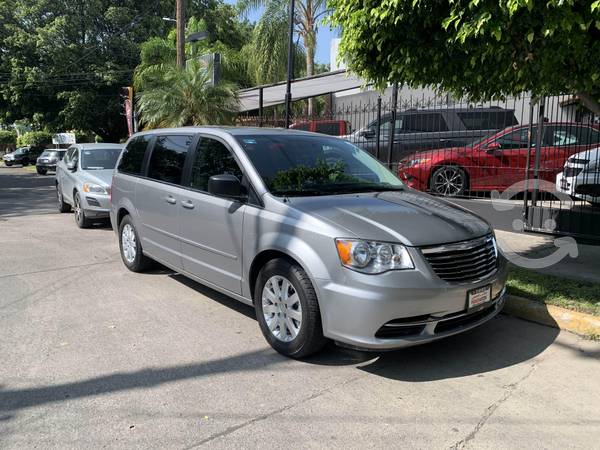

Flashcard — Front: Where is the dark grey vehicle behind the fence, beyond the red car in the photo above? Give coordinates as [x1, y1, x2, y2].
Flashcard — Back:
[344, 107, 518, 163]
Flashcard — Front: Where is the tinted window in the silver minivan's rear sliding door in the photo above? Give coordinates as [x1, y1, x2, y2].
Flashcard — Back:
[148, 136, 192, 184]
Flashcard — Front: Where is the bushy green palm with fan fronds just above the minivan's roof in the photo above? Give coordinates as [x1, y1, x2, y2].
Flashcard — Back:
[135, 60, 238, 128]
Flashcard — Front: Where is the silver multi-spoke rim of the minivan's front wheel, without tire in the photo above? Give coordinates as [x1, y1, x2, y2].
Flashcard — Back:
[262, 275, 302, 342]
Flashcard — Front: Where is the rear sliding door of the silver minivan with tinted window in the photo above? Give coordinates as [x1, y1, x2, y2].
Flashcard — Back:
[135, 135, 192, 269]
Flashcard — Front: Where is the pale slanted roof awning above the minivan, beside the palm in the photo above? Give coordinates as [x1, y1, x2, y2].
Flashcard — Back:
[238, 70, 365, 112]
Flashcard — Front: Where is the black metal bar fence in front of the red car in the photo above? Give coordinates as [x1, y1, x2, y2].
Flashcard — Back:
[239, 90, 600, 239]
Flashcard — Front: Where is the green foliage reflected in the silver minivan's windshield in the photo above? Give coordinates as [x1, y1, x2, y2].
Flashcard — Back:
[269, 160, 355, 192]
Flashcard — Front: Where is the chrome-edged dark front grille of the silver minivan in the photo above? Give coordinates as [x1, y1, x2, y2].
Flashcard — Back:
[421, 236, 498, 283]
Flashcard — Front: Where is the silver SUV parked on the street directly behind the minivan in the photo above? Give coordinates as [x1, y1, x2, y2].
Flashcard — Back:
[55, 144, 123, 228]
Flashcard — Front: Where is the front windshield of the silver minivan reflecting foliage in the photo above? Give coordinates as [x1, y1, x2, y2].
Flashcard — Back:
[236, 134, 403, 196]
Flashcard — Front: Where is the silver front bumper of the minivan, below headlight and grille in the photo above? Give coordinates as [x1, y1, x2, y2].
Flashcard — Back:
[316, 257, 507, 350]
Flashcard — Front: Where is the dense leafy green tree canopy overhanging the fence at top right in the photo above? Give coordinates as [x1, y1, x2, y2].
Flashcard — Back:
[329, 0, 600, 114]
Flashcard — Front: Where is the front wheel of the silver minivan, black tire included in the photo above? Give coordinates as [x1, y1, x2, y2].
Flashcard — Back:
[254, 258, 327, 358]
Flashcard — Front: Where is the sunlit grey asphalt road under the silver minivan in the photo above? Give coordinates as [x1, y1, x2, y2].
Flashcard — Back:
[0, 169, 600, 449]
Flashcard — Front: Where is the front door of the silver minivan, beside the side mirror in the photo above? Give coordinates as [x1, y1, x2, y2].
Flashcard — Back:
[178, 136, 246, 294]
